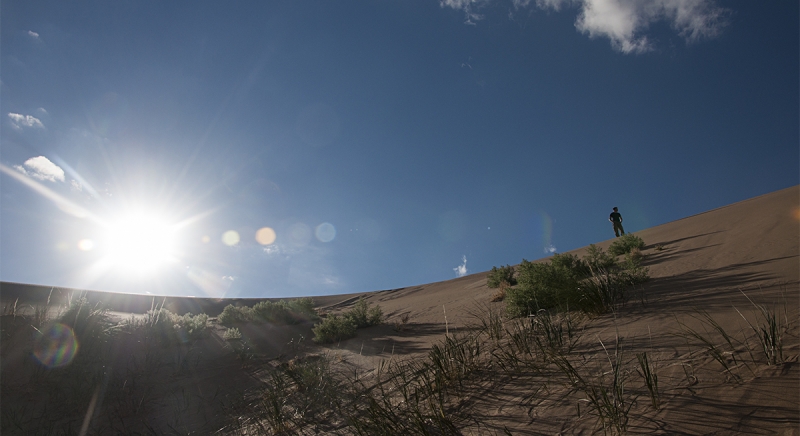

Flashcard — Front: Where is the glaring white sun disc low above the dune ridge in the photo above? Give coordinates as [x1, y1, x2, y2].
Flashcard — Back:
[103, 212, 177, 273]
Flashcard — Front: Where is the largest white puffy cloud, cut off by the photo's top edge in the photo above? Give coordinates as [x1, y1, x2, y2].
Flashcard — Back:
[440, 0, 729, 53]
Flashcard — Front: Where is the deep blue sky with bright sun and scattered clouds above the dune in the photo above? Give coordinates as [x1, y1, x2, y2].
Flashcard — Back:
[0, 0, 800, 297]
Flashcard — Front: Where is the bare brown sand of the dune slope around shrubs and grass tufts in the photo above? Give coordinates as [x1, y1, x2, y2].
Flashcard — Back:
[0, 186, 800, 435]
